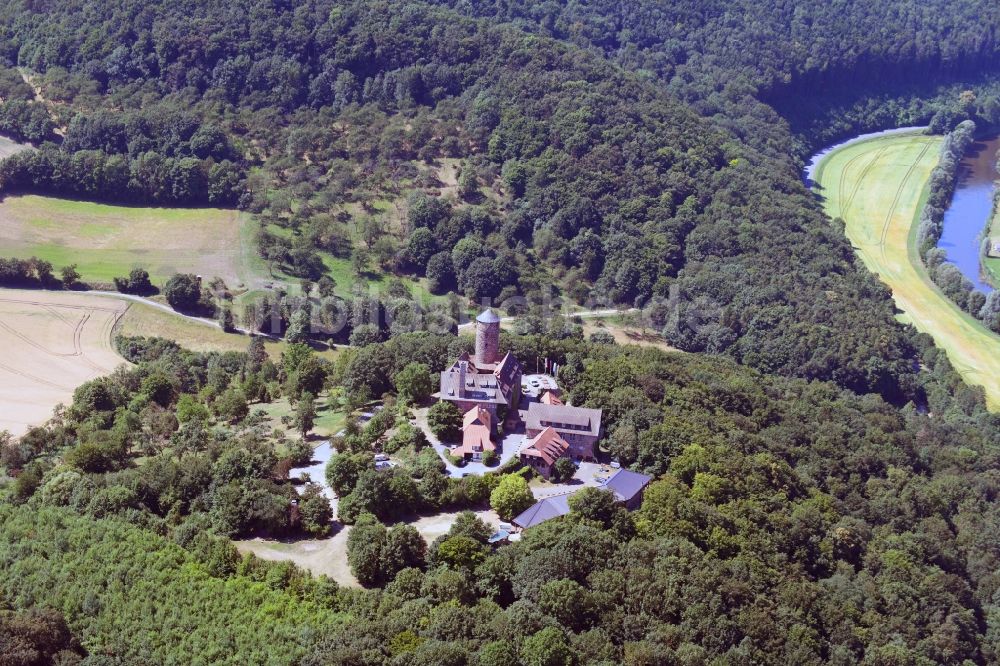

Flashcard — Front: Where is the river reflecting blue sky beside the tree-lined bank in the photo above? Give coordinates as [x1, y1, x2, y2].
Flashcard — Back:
[938, 137, 1000, 292]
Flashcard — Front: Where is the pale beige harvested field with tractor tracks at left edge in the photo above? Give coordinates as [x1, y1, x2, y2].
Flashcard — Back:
[0, 289, 127, 435]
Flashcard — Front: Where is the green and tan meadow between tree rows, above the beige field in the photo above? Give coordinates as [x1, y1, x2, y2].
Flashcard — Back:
[0, 195, 268, 288]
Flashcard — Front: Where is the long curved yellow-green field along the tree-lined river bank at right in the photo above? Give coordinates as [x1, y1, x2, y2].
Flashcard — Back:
[815, 129, 1000, 410]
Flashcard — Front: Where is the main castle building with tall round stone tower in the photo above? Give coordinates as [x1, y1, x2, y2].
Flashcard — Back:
[435, 309, 523, 420]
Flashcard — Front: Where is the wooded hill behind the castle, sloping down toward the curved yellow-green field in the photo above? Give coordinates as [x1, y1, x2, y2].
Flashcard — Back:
[0, 1, 952, 401]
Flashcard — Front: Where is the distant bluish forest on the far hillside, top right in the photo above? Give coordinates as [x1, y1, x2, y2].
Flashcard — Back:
[426, 0, 1000, 153]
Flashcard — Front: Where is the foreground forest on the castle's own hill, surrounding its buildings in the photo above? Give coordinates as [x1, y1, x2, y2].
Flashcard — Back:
[0, 334, 1000, 665]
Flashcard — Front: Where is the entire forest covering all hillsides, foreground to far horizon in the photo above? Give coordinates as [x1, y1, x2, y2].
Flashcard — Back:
[0, 0, 1000, 666]
